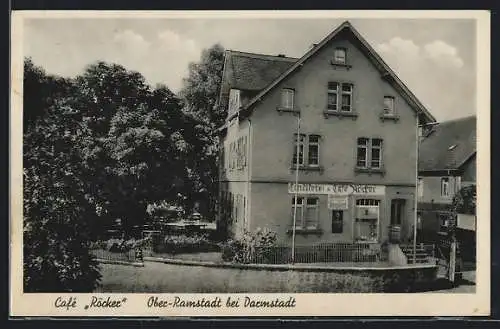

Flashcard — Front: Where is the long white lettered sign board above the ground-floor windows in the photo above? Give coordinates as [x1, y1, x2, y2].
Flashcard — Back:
[288, 183, 385, 196]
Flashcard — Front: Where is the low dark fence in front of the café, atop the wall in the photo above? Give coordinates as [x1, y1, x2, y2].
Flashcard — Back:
[250, 243, 387, 264]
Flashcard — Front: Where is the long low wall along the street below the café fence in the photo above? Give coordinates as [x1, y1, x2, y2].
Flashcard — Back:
[134, 257, 437, 293]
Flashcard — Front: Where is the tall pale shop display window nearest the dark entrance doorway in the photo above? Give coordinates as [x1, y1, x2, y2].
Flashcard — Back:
[354, 199, 380, 242]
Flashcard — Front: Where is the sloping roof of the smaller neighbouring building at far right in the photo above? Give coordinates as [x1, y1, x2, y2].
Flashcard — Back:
[418, 116, 476, 172]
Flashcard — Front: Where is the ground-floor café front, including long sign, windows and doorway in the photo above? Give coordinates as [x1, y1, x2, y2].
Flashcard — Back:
[247, 183, 414, 244]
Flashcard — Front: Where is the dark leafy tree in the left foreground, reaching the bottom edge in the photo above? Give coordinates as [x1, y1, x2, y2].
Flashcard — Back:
[23, 99, 100, 292]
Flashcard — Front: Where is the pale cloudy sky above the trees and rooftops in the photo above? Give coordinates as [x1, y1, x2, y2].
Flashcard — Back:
[23, 17, 477, 121]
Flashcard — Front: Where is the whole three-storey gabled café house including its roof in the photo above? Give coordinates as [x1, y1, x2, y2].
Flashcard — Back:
[218, 22, 435, 244]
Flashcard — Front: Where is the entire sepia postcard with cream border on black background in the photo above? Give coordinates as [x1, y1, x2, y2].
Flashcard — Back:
[11, 11, 490, 315]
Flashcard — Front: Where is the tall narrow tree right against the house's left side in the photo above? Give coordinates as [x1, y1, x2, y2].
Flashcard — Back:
[180, 44, 227, 217]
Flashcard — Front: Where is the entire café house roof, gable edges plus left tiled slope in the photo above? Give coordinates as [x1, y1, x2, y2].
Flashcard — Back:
[219, 21, 436, 123]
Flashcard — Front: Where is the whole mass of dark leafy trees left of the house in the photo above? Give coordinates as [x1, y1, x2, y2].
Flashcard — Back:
[23, 45, 225, 292]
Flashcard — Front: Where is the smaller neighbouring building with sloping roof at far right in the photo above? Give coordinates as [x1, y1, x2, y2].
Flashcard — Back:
[418, 116, 476, 242]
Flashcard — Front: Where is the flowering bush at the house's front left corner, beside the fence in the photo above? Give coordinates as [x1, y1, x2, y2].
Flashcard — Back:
[222, 228, 276, 263]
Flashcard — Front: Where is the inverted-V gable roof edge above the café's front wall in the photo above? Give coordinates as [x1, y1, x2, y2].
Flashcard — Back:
[233, 21, 436, 123]
